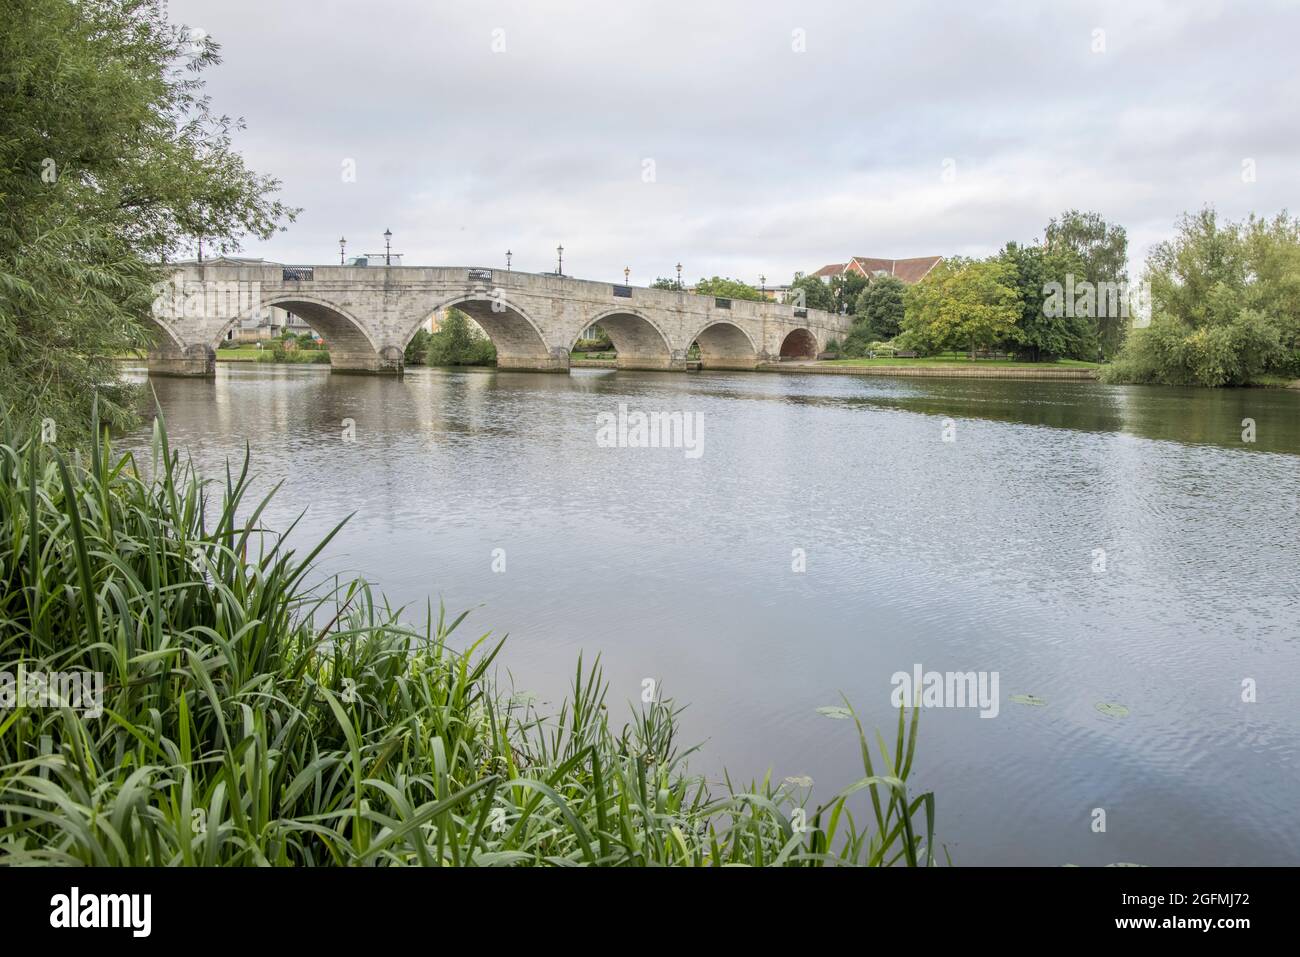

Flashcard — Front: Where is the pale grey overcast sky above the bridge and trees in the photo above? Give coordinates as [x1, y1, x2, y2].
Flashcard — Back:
[170, 0, 1300, 285]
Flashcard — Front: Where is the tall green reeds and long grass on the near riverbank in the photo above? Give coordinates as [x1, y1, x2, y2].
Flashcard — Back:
[0, 421, 933, 866]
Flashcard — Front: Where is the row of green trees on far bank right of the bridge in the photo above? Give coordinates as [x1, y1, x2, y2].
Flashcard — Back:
[792, 208, 1300, 386]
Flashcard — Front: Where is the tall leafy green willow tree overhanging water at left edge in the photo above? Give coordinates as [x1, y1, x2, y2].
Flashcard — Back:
[0, 0, 296, 441]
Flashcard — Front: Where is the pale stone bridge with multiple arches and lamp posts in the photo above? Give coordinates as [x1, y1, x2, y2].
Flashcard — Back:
[150, 261, 850, 376]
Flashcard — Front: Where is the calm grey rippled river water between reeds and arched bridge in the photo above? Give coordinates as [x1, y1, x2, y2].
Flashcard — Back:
[129, 365, 1300, 865]
